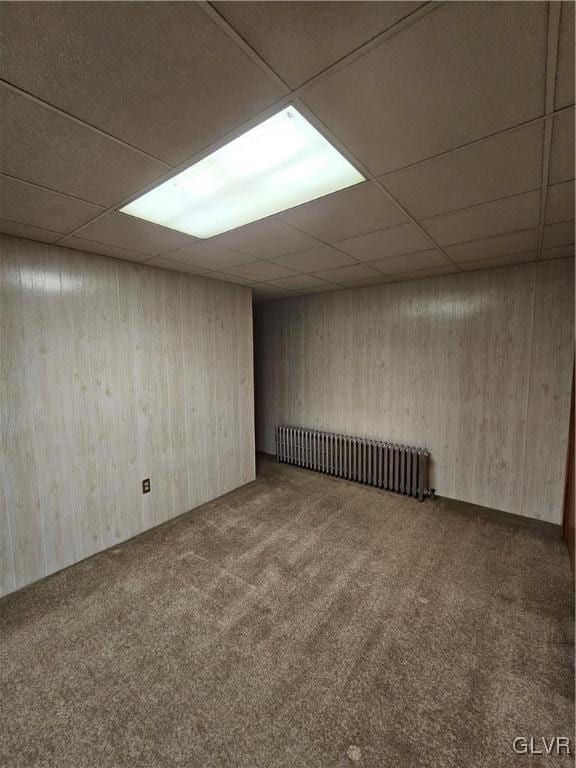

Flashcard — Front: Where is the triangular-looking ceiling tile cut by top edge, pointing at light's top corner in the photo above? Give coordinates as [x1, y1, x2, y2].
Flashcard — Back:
[213, 2, 423, 88]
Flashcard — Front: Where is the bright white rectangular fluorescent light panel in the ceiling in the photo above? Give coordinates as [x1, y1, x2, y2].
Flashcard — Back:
[120, 106, 365, 238]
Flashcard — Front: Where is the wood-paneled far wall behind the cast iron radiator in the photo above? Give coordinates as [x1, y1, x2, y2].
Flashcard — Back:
[255, 259, 574, 523]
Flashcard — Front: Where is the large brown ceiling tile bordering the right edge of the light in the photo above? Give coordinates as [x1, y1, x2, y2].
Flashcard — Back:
[302, 3, 547, 175]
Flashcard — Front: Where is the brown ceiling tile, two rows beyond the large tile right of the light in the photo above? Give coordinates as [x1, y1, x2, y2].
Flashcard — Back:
[420, 190, 540, 245]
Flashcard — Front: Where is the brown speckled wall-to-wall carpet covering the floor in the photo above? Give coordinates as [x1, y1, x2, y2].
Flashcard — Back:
[0, 452, 574, 768]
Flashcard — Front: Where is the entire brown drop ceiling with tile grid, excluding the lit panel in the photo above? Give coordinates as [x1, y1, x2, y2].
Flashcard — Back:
[0, 2, 574, 299]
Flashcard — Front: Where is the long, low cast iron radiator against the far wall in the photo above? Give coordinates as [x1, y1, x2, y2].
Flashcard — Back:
[276, 426, 430, 501]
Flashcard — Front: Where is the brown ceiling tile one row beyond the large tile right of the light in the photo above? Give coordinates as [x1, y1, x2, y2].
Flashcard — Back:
[382, 123, 544, 219]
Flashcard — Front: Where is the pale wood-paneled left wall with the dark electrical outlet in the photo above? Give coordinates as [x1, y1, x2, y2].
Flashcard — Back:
[0, 237, 255, 594]
